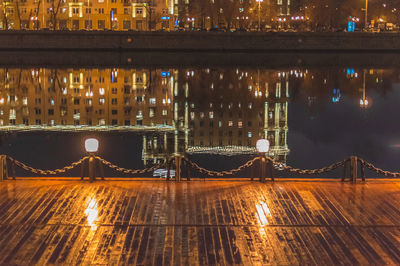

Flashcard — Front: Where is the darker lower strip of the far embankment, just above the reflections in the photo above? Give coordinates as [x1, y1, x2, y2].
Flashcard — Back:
[0, 51, 400, 69]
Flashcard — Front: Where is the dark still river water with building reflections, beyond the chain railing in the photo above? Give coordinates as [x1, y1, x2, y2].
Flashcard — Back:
[0, 62, 400, 176]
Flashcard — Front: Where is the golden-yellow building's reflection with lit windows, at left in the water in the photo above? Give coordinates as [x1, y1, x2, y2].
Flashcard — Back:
[0, 69, 173, 127]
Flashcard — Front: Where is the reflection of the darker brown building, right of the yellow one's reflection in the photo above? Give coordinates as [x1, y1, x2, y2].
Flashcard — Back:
[178, 70, 289, 161]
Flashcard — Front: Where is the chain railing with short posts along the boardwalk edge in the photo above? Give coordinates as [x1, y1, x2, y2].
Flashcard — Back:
[0, 154, 400, 182]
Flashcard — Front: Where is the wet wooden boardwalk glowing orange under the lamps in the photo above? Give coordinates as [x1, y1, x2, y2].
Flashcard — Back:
[0, 180, 400, 265]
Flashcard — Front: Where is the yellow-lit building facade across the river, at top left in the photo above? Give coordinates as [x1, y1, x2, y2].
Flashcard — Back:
[0, 0, 175, 31]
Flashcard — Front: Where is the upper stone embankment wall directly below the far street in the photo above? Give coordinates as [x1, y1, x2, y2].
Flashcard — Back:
[0, 31, 400, 52]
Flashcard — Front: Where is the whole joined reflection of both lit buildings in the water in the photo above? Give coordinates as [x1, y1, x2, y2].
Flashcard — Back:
[0, 68, 289, 166]
